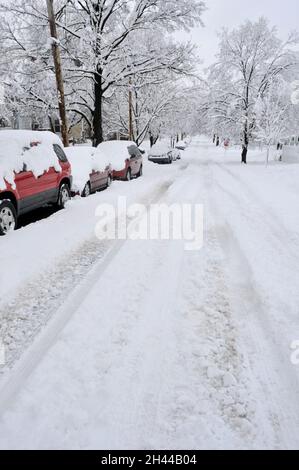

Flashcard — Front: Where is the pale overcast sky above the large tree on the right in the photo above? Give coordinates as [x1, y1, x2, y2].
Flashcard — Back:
[184, 0, 299, 65]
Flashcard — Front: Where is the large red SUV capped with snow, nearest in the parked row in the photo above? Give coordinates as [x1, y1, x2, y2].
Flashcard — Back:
[0, 131, 72, 235]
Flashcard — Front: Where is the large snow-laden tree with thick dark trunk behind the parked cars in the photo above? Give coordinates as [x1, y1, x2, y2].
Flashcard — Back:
[0, 0, 204, 144]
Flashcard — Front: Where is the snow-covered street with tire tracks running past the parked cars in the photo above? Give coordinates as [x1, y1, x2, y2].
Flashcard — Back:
[0, 139, 299, 449]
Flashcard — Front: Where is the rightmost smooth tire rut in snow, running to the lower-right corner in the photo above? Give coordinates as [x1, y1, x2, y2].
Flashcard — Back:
[212, 217, 299, 449]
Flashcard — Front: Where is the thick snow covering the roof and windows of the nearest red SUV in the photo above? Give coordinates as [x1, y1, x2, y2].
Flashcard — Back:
[0, 131, 63, 190]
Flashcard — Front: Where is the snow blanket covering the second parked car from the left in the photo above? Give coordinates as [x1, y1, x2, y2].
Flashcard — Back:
[65, 146, 109, 193]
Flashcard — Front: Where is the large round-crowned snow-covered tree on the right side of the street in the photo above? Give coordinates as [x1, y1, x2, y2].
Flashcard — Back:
[207, 18, 298, 163]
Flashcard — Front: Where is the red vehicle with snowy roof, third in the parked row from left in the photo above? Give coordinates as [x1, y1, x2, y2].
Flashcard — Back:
[98, 140, 143, 181]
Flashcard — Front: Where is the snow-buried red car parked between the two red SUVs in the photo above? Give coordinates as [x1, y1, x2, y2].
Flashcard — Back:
[65, 146, 113, 197]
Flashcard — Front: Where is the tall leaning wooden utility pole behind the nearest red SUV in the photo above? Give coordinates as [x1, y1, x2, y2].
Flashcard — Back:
[46, 0, 69, 147]
